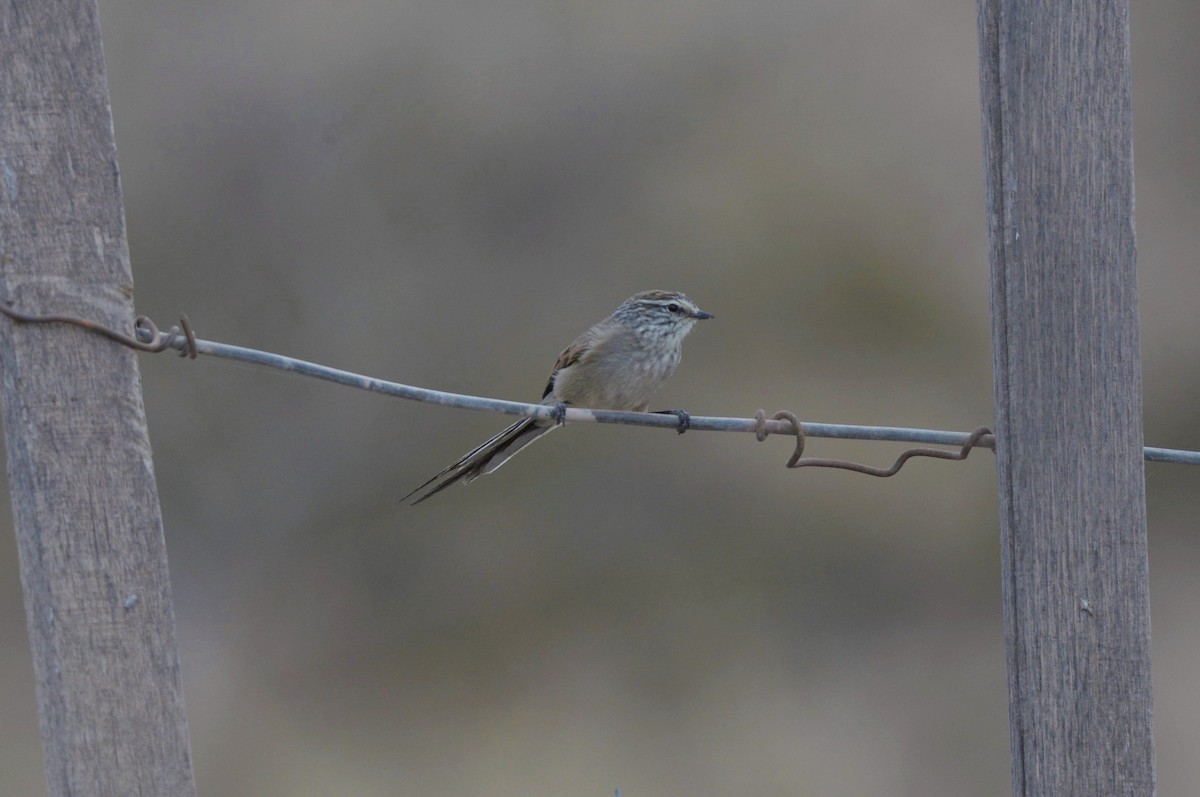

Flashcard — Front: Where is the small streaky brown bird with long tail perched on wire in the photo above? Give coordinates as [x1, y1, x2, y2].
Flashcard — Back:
[401, 290, 713, 507]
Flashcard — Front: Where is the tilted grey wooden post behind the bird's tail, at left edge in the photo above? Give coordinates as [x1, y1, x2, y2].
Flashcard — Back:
[0, 0, 196, 797]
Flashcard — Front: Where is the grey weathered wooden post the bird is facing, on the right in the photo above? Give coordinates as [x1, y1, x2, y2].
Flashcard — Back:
[979, 0, 1154, 797]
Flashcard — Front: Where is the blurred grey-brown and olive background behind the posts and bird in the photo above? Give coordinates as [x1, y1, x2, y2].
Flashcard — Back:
[0, 0, 1200, 797]
